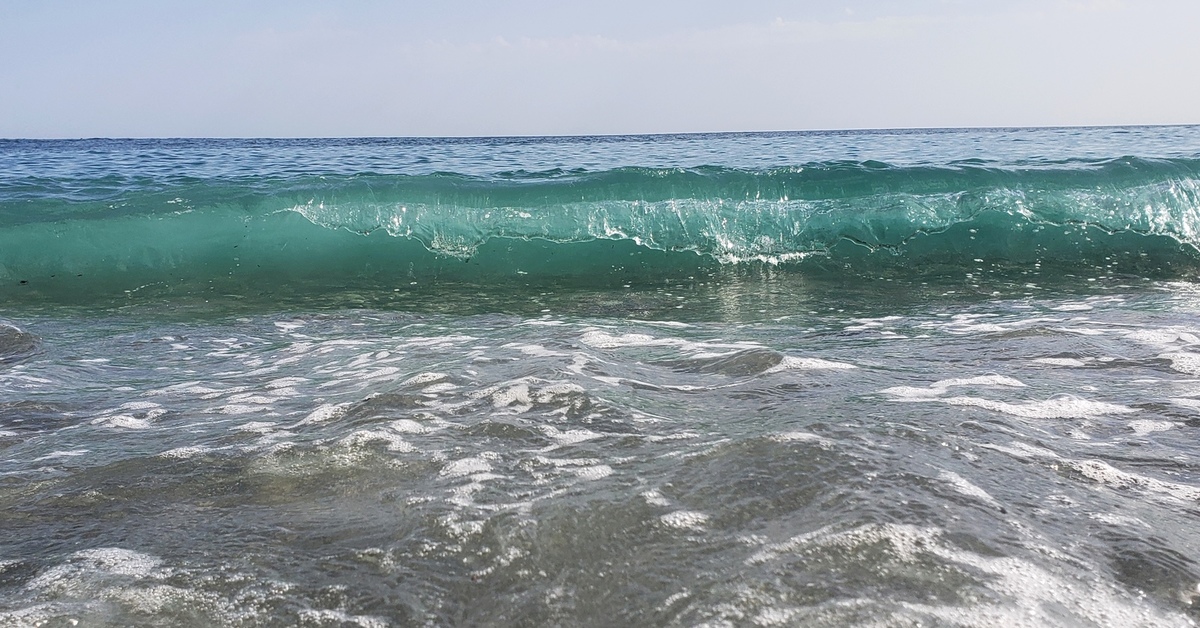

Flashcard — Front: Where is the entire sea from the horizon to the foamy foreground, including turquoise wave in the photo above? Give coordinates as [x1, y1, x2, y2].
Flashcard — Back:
[0, 126, 1200, 627]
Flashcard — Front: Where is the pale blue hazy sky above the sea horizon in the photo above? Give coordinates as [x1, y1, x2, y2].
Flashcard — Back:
[0, 0, 1200, 138]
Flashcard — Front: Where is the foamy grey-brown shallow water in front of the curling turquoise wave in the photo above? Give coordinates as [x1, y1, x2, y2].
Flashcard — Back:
[0, 130, 1200, 627]
